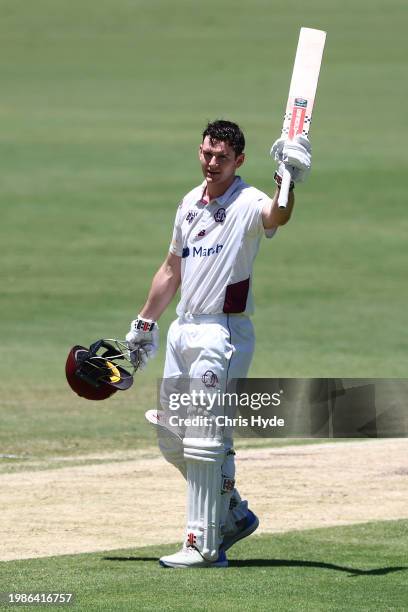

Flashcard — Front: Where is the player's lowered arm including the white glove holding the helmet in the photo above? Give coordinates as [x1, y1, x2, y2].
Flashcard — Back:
[126, 253, 181, 368]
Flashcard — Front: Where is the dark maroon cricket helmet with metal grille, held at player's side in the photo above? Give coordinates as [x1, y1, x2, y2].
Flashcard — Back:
[65, 340, 136, 400]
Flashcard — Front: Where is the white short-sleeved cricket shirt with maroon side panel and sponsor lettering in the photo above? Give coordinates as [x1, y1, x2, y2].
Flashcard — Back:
[170, 176, 276, 316]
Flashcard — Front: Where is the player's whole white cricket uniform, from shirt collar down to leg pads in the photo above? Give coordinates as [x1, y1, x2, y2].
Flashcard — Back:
[159, 177, 276, 559]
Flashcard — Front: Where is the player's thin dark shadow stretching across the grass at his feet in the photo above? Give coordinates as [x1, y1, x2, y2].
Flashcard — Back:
[103, 557, 408, 578]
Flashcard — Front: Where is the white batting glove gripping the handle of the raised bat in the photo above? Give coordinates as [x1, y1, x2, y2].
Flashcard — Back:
[271, 134, 312, 183]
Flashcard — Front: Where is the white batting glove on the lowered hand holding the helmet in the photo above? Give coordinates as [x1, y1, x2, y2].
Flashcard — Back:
[126, 315, 159, 370]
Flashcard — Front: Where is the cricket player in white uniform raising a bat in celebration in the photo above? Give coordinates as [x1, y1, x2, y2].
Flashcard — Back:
[126, 120, 311, 568]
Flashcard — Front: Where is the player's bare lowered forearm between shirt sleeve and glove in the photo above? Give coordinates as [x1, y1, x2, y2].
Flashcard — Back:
[140, 253, 181, 321]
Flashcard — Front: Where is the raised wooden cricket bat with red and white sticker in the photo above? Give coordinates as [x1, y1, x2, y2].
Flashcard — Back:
[278, 28, 326, 208]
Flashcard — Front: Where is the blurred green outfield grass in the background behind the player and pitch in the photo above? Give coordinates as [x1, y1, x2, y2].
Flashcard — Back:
[0, 0, 408, 456]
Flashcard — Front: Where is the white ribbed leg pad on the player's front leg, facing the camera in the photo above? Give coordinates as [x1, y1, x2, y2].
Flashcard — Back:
[183, 438, 225, 561]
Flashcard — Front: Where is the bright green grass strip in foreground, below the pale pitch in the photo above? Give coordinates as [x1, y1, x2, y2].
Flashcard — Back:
[0, 521, 408, 612]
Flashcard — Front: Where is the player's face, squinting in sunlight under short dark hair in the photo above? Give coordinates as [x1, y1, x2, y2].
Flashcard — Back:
[199, 136, 245, 185]
